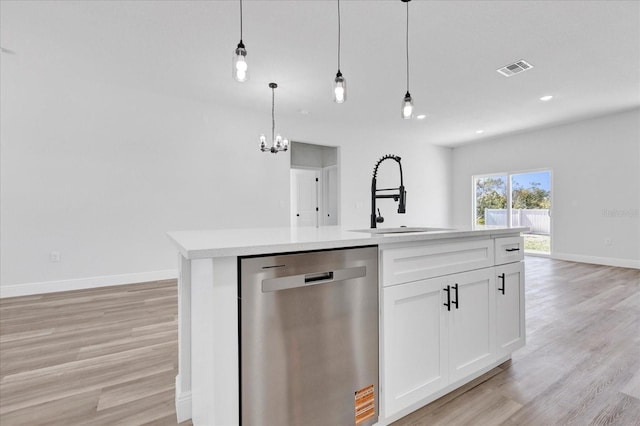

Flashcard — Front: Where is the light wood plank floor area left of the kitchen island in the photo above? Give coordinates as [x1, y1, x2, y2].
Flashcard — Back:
[0, 280, 189, 426]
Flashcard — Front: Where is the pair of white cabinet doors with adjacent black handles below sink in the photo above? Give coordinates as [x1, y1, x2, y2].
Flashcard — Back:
[383, 268, 495, 416]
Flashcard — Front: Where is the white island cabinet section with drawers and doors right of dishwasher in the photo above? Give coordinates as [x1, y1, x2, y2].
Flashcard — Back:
[380, 236, 525, 424]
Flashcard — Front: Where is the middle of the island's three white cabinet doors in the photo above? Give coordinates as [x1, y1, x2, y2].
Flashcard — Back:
[443, 268, 496, 383]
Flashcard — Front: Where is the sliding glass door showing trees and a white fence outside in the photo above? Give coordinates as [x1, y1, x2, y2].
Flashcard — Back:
[473, 170, 552, 255]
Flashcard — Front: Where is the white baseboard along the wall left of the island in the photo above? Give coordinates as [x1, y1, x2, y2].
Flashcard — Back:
[0, 269, 178, 298]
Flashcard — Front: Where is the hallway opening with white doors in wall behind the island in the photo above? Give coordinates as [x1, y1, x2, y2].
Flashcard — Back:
[290, 142, 340, 227]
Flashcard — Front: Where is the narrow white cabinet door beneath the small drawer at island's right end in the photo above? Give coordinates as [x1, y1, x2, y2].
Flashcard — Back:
[495, 262, 525, 357]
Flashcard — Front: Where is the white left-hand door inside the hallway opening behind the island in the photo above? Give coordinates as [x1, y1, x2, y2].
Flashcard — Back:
[291, 169, 320, 226]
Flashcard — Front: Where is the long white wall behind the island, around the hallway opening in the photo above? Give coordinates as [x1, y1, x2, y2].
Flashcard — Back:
[0, 60, 451, 296]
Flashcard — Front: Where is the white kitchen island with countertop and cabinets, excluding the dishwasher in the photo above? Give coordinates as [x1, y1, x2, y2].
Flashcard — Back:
[169, 227, 527, 426]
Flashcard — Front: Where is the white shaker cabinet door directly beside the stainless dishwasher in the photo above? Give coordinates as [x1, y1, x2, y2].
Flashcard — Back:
[383, 278, 448, 417]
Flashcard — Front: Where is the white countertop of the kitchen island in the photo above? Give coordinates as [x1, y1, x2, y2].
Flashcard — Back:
[168, 226, 529, 259]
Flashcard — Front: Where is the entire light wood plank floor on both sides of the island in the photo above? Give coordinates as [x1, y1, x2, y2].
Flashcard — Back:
[0, 257, 640, 426]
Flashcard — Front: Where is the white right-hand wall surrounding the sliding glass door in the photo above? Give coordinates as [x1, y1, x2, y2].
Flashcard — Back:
[453, 109, 640, 268]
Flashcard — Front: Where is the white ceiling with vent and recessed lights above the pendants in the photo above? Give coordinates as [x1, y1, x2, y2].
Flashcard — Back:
[0, 0, 640, 146]
